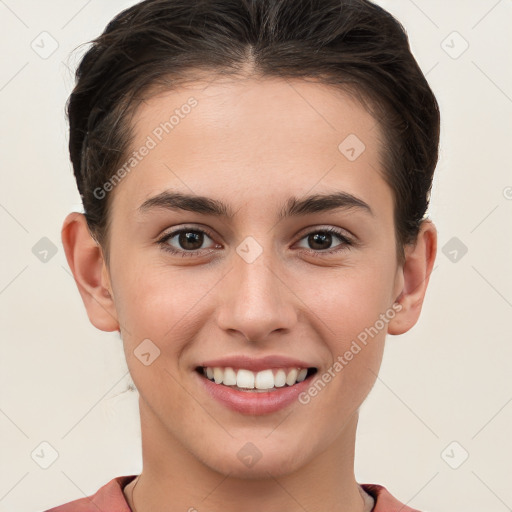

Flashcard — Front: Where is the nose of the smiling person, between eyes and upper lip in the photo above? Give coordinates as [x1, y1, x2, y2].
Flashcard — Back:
[217, 245, 297, 342]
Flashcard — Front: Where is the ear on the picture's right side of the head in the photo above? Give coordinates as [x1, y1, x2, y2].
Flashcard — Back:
[388, 220, 437, 334]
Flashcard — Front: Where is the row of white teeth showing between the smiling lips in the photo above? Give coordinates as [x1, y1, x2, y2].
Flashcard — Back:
[195, 366, 317, 393]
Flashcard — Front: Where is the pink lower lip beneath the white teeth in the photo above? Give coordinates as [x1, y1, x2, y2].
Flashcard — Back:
[194, 372, 316, 415]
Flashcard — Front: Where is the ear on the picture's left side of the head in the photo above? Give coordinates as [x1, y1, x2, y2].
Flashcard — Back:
[61, 212, 119, 331]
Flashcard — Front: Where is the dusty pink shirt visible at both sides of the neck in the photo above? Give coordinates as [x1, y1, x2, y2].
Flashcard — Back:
[46, 475, 419, 512]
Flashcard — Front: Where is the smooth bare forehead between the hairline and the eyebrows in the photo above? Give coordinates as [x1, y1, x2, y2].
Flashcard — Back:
[111, 78, 389, 218]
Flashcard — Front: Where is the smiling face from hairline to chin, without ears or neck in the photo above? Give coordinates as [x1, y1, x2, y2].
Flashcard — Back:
[101, 79, 403, 477]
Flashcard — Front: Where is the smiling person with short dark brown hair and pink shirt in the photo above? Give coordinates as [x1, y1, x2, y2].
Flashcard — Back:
[52, 0, 439, 512]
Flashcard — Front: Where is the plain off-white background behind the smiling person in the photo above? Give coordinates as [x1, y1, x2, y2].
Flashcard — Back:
[0, 0, 512, 512]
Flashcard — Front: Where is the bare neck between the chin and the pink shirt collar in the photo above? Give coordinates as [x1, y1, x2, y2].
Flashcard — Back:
[124, 401, 365, 512]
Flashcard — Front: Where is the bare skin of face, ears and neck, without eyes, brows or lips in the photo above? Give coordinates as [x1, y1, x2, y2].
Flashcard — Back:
[62, 78, 437, 512]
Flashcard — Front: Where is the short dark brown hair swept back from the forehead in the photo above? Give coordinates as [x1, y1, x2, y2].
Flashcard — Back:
[67, 0, 440, 258]
